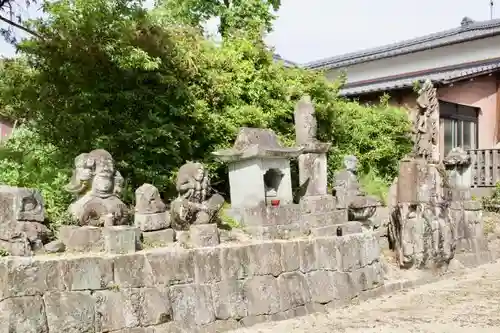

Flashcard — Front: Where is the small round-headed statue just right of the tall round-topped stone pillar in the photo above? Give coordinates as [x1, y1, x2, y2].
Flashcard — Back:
[334, 155, 380, 226]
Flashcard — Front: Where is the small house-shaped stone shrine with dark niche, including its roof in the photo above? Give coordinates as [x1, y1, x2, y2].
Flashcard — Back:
[213, 127, 303, 209]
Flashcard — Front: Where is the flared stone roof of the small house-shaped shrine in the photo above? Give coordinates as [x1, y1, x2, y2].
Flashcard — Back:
[213, 127, 303, 162]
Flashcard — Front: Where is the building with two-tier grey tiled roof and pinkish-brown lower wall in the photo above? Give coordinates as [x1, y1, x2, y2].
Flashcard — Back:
[304, 17, 500, 187]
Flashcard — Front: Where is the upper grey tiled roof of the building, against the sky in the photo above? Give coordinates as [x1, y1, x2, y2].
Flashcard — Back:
[304, 18, 500, 69]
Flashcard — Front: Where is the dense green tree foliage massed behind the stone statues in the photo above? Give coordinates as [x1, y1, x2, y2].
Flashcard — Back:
[0, 0, 410, 226]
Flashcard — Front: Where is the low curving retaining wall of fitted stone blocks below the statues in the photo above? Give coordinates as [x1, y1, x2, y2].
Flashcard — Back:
[0, 233, 383, 333]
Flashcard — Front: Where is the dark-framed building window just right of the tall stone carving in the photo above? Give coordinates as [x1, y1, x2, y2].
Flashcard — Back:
[439, 101, 479, 157]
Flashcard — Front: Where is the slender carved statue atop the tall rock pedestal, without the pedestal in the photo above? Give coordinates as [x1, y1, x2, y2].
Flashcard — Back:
[411, 80, 439, 163]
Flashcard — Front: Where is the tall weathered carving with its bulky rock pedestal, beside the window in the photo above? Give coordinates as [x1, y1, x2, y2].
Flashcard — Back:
[388, 80, 457, 268]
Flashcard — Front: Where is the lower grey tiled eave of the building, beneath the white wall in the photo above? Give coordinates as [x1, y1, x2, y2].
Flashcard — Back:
[340, 61, 500, 97]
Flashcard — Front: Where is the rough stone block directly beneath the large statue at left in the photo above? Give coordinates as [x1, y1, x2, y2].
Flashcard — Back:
[59, 225, 104, 252]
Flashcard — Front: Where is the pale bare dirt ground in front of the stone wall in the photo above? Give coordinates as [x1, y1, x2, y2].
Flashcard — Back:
[231, 261, 500, 333]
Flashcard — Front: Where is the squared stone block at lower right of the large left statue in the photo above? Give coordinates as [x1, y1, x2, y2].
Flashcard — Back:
[103, 225, 142, 254]
